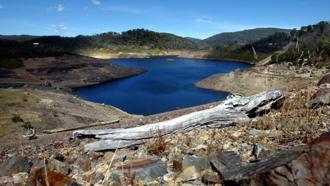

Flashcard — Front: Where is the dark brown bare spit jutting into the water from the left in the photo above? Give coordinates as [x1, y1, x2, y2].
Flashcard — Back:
[0, 55, 143, 88]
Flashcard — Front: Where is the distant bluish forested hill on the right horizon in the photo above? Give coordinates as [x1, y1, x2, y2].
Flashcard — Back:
[204, 28, 290, 46]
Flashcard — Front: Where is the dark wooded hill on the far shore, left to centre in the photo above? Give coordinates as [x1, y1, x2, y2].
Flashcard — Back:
[0, 29, 204, 58]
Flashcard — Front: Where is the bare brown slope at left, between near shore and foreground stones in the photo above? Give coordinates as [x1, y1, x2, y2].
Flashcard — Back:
[0, 88, 141, 149]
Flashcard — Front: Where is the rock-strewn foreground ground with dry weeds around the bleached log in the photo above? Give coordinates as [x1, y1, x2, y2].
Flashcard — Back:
[0, 73, 330, 185]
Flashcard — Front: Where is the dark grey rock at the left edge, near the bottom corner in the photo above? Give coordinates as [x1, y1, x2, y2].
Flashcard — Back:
[0, 157, 32, 176]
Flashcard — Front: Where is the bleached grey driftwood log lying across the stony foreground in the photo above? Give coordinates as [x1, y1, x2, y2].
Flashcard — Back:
[73, 90, 284, 151]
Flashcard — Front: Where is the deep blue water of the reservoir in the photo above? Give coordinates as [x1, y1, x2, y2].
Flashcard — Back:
[75, 57, 252, 115]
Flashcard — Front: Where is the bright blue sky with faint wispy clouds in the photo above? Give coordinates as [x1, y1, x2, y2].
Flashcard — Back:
[0, 0, 330, 38]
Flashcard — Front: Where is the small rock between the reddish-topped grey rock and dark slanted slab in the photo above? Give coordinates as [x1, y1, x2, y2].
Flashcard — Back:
[182, 155, 211, 172]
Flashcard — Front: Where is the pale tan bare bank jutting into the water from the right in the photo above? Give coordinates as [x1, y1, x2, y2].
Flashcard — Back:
[196, 64, 327, 95]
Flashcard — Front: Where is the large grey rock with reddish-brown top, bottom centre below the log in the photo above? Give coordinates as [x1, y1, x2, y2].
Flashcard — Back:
[111, 159, 167, 182]
